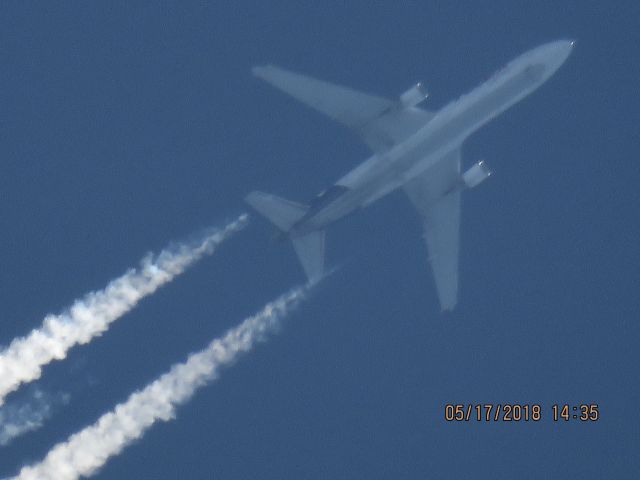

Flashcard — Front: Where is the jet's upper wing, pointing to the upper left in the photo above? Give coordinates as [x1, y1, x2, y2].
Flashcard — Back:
[252, 65, 433, 152]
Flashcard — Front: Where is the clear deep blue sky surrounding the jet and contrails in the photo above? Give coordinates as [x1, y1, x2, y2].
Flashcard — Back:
[0, 1, 640, 480]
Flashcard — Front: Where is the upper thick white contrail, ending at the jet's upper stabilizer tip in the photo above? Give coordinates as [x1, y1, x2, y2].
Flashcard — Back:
[0, 214, 248, 405]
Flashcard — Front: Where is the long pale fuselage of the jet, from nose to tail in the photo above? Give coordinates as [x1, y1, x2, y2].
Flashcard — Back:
[289, 40, 573, 236]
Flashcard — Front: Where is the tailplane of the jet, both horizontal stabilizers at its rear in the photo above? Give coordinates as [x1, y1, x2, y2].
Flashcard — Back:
[245, 192, 325, 281]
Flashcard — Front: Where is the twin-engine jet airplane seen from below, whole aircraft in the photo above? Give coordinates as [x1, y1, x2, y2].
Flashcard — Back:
[245, 40, 575, 311]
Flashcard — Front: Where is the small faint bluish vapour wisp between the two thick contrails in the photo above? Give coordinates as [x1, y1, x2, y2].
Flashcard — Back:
[0, 389, 70, 447]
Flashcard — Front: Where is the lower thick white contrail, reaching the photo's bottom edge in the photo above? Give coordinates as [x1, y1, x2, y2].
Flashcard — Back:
[14, 286, 309, 480]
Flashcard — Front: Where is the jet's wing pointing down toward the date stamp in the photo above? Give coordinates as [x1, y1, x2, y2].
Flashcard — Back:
[403, 148, 461, 310]
